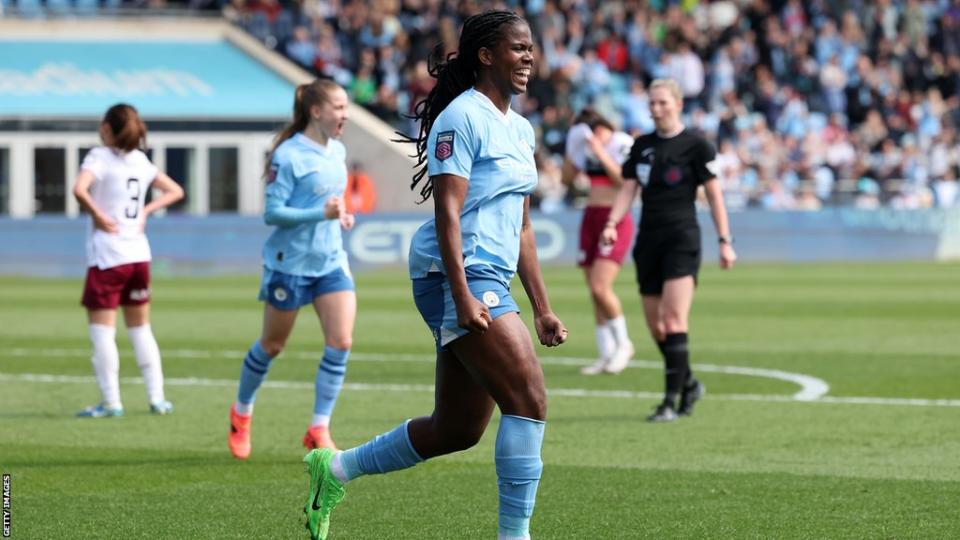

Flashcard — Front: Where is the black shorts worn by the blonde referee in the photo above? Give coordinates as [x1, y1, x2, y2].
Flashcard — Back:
[633, 227, 701, 296]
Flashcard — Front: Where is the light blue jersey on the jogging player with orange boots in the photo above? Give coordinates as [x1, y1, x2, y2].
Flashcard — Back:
[263, 133, 347, 276]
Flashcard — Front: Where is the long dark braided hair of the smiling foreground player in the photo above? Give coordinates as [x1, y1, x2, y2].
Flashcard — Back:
[397, 11, 526, 203]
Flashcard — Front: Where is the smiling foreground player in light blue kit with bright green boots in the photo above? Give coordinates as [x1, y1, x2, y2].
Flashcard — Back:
[304, 11, 567, 540]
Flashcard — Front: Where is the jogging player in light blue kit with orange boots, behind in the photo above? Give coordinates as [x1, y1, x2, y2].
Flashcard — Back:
[227, 80, 357, 459]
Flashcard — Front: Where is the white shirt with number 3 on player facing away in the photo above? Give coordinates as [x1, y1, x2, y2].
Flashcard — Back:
[80, 146, 157, 270]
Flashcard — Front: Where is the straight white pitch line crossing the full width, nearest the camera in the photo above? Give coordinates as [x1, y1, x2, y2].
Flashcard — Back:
[0, 373, 960, 408]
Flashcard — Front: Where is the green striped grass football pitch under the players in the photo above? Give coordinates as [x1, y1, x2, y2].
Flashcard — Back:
[0, 263, 960, 540]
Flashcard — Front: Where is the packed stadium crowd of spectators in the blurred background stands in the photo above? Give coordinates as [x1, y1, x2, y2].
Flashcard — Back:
[225, 0, 960, 209]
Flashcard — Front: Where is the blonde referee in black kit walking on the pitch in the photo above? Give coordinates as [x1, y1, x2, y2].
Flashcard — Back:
[601, 79, 737, 422]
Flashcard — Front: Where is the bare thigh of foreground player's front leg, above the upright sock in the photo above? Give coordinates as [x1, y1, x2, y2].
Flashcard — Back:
[450, 312, 546, 420]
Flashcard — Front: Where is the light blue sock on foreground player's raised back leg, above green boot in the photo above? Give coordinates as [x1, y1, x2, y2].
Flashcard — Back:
[340, 420, 423, 481]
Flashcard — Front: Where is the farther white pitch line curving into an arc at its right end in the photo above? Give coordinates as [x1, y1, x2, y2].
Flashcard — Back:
[6, 348, 830, 401]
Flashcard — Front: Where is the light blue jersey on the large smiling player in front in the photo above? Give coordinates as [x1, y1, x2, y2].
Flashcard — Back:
[409, 88, 537, 284]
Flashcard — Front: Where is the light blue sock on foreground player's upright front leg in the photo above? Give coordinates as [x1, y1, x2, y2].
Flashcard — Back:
[494, 414, 546, 538]
